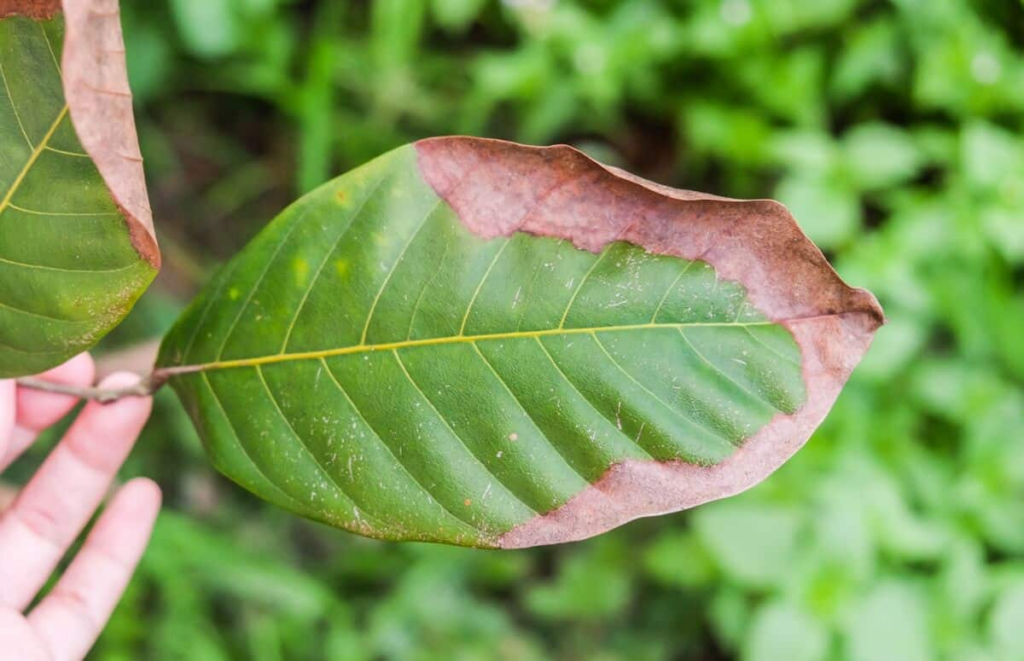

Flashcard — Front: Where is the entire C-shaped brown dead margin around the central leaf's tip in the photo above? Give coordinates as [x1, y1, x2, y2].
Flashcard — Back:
[417, 137, 884, 548]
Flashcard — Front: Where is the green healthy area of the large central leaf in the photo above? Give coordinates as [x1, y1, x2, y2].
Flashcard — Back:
[159, 147, 805, 545]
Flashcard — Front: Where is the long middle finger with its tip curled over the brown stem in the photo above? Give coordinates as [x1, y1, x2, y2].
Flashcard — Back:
[0, 372, 152, 610]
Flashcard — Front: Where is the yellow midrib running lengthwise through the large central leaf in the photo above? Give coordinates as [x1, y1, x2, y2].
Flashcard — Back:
[167, 321, 774, 376]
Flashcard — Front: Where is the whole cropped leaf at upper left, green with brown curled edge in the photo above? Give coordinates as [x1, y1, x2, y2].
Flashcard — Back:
[0, 0, 160, 378]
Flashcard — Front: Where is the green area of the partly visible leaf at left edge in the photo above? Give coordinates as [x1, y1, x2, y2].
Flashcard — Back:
[0, 16, 155, 377]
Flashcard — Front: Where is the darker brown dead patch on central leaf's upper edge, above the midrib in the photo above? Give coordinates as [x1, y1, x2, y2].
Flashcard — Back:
[417, 137, 883, 324]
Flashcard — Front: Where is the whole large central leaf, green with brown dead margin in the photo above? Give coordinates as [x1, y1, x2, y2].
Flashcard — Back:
[157, 138, 882, 547]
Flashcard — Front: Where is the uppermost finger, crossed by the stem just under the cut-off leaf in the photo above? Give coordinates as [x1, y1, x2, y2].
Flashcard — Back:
[0, 353, 96, 471]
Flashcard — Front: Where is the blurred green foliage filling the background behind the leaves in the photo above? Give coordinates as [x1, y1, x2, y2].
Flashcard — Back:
[25, 0, 1024, 661]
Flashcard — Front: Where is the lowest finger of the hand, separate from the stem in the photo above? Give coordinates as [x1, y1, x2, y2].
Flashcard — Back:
[29, 478, 160, 660]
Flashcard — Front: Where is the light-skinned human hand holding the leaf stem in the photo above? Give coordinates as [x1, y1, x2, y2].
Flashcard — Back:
[0, 354, 161, 661]
